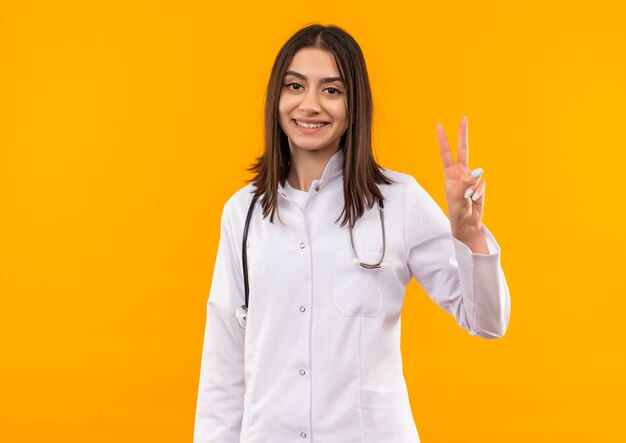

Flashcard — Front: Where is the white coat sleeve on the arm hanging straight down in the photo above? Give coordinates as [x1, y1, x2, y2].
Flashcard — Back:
[193, 202, 245, 443]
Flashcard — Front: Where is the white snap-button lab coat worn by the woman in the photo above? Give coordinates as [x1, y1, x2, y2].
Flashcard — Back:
[194, 150, 510, 443]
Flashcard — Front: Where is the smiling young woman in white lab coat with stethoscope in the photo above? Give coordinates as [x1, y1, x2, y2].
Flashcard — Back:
[194, 25, 510, 443]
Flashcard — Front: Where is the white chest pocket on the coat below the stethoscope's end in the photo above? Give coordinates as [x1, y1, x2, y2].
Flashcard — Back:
[332, 251, 385, 317]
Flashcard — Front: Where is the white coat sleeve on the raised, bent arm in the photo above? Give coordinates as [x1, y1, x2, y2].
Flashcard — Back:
[404, 176, 511, 339]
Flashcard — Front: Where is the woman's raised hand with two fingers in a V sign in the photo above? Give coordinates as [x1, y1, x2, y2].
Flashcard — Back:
[437, 117, 489, 254]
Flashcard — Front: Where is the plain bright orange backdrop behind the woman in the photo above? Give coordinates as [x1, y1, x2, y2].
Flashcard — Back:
[0, 0, 626, 443]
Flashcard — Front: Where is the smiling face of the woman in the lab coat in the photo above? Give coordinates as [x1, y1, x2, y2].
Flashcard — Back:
[278, 48, 348, 153]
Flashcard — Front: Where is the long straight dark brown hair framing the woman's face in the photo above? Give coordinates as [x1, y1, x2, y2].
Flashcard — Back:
[247, 24, 392, 227]
